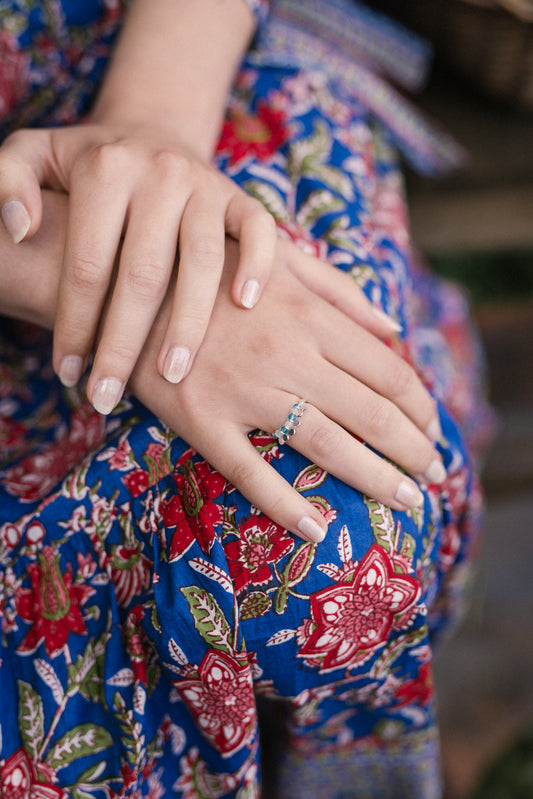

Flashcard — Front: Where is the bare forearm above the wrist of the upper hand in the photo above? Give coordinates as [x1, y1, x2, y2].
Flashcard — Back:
[93, 0, 254, 158]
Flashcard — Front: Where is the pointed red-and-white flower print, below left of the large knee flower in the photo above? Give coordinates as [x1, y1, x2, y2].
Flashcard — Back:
[174, 649, 256, 757]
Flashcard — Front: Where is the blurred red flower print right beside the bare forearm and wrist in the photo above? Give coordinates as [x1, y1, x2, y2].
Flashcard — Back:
[217, 103, 289, 166]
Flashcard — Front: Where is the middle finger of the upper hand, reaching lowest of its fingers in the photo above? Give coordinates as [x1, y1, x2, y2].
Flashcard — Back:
[87, 181, 181, 413]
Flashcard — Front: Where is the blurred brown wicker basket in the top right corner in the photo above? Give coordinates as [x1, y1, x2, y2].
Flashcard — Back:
[374, 0, 533, 111]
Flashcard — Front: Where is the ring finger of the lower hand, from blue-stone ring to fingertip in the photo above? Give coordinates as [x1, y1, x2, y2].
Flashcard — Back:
[266, 402, 424, 510]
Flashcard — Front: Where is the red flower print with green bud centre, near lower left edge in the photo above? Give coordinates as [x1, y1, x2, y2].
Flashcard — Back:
[15, 546, 94, 657]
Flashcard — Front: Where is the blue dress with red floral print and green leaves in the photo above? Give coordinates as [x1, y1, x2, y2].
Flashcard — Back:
[0, 0, 490, 799]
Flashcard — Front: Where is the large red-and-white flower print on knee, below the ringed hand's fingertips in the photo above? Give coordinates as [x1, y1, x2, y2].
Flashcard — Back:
[298, 545, 419, 673]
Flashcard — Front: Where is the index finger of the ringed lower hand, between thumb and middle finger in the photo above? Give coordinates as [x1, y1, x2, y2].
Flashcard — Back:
[317, 312, 441, 442]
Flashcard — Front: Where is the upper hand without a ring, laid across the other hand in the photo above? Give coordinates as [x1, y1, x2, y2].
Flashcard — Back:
[0, 122, 276, 413]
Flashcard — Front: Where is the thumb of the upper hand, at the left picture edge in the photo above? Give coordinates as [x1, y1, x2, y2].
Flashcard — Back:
[0, 130, 55, 244]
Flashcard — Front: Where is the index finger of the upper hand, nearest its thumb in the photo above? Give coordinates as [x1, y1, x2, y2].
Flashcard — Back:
[53, 159, 130, 386]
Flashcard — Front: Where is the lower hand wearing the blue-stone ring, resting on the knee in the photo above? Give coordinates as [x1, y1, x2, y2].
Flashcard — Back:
[131, 234, 446, 541]
